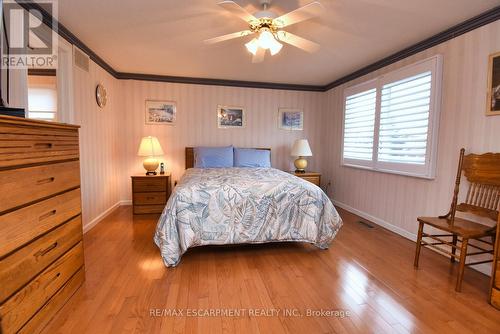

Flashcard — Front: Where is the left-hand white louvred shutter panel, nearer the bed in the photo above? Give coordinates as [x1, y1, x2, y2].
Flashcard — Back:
[343, 88, 377, 161]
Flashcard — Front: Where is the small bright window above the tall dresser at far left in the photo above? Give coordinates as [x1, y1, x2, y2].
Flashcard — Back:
[28, 71, 57, 121]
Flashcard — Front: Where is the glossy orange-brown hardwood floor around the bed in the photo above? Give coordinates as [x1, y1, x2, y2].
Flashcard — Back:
[40, 207, 500, 333]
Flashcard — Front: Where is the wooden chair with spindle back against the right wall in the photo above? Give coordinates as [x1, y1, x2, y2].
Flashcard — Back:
[414, 148, 500, 292]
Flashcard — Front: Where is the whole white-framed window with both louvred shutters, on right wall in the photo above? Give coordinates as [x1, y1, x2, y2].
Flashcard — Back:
[342, 56, 442, 178]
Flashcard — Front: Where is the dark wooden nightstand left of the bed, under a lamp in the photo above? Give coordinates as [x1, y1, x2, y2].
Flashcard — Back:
[132, 173, 170, 215]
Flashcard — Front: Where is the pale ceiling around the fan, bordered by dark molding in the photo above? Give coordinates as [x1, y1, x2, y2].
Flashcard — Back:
[59, 0, 500, 85]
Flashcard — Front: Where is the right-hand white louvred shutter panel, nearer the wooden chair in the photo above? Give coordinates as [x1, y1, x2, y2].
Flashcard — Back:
[378, 71, 432, 165]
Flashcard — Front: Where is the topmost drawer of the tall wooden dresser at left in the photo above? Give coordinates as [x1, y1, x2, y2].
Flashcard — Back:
[0, 125, 79, 168]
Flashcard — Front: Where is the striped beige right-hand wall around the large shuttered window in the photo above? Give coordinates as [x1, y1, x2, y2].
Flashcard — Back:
[322, 21, 500, 243]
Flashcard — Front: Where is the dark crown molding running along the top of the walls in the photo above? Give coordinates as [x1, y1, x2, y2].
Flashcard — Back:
[16, 0, 500, 92]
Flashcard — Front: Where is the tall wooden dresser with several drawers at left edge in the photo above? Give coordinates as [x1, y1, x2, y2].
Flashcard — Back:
[0, 116, 85, 334]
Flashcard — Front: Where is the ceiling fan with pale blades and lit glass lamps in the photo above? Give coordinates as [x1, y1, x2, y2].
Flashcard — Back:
[205, 0, 323, 63]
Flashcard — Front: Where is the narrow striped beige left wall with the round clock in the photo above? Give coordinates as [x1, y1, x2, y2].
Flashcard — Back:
[73, 62, 123, 229]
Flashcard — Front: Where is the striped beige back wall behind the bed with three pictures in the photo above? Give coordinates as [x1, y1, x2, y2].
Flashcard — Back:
[120, 80, 325, 199]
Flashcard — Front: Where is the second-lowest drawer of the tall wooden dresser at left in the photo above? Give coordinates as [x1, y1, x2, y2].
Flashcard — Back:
[0, 216, 82, 303]
